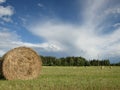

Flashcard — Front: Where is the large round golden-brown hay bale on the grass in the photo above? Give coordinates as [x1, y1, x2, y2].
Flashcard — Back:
[2, 47, 42, 80]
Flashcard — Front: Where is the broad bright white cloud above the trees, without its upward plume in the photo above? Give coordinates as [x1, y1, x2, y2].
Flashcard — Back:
[27, 22, 120, 59]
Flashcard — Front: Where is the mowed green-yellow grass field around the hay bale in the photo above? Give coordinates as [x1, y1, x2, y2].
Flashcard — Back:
[0, 66, 120, 90]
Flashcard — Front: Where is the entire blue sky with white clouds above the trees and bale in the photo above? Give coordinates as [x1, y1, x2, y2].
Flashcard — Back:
[0, 0, 120, 62]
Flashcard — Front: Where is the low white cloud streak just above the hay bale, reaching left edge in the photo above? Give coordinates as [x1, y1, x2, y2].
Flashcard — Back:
[0, 28, 61, 56]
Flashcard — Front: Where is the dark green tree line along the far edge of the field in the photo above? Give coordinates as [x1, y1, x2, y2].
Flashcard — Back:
[41, 56, 120, 66]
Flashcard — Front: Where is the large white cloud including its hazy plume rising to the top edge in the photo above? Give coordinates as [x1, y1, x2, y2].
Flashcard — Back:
[28, 0, 120, 59]
